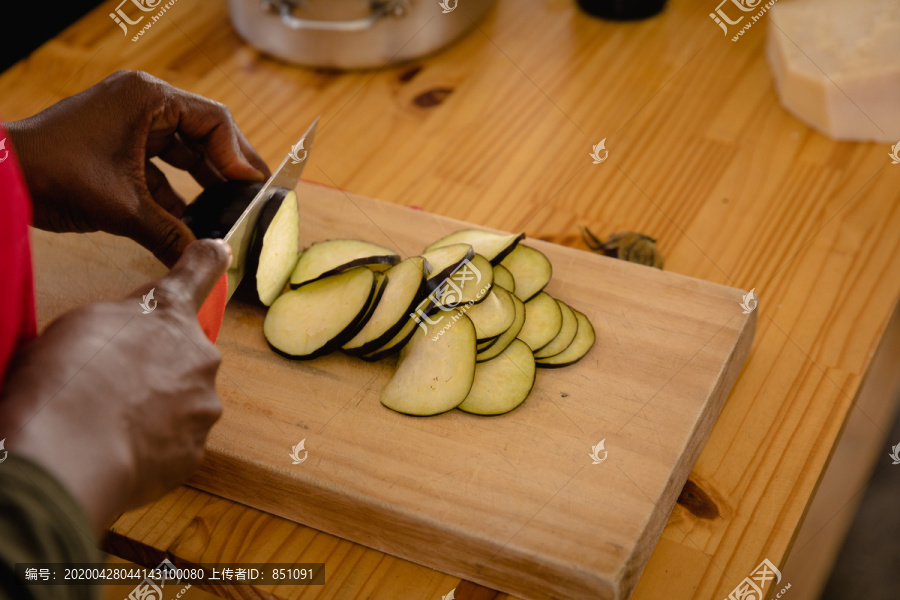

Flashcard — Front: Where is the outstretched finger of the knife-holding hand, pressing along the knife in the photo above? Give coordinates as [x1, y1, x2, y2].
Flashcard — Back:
[158, 239, 231, 313]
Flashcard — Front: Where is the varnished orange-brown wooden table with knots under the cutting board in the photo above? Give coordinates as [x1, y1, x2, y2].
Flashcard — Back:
[0, 0, 900, 600]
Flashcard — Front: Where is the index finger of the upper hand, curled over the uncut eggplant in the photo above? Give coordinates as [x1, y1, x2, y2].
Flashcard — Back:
[151, 89, 266, 181]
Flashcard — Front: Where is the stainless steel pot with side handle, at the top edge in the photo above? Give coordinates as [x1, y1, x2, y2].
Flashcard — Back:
[228, 0, 494, 69]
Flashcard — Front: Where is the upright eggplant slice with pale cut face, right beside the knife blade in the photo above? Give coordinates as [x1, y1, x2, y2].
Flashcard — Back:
[253, 190, 300, 306]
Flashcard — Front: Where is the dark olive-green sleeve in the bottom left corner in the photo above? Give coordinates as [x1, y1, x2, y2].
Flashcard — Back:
[0, 452, 104, 600]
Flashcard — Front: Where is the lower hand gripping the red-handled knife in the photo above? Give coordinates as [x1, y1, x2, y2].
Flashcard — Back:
[0, 240, 231, 534]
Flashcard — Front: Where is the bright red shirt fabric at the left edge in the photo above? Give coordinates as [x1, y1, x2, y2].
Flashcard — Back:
[0, 127, 37, 389]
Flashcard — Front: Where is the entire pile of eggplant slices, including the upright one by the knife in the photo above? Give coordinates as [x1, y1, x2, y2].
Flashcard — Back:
[256, 226, 594, 416]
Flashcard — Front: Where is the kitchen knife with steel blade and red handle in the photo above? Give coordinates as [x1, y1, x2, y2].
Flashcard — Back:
[197, 117, 319, 343]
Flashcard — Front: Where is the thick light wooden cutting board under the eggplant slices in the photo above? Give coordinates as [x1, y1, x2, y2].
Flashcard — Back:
[35, 183, 756, 600]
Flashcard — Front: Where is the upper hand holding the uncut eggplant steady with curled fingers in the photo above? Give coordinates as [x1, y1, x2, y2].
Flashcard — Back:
[5, 71, 269, 267]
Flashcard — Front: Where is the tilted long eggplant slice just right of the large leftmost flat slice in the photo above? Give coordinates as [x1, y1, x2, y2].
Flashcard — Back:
[343, 256, 425, 356]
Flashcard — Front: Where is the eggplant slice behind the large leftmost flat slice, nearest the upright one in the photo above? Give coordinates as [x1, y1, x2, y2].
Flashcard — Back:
[291, 240, 400, 289]
